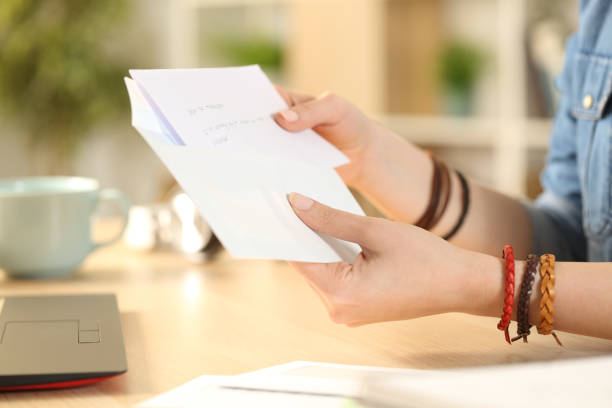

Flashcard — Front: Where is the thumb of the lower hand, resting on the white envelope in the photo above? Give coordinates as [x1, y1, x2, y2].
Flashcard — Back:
[288, 193, 384, 251]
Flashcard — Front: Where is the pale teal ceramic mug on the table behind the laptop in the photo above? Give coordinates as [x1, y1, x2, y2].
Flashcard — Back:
[0, 177, 129, 278]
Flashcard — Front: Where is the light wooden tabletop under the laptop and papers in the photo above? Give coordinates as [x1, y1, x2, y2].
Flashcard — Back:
[0, 245, 612, 407]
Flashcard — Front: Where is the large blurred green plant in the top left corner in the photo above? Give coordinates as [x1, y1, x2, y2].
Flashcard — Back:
[0, 0, 127, 166]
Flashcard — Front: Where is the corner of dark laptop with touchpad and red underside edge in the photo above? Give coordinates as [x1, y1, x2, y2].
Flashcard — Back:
[0, 294, 127, 391]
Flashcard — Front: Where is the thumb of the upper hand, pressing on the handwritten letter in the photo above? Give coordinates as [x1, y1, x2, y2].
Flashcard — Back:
[274, 93, 346, 132]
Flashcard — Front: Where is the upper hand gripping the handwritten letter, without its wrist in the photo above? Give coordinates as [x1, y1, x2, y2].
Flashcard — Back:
[274, 86, 384, 186]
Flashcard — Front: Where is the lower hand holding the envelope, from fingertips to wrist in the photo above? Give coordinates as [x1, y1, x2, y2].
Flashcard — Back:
[289, 193, 492, 326]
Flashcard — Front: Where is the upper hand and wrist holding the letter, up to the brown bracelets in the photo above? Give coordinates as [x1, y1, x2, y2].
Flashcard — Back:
[274, 87, 436, 226]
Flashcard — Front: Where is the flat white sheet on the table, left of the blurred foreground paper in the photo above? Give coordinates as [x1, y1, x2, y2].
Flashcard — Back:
[138, 361, 426, 408]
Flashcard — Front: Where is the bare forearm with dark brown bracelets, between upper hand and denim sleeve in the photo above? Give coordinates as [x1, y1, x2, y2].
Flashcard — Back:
[355, 127, 532, 257]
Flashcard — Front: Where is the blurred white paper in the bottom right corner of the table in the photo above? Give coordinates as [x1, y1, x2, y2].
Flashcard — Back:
[361, 357, 612, 408]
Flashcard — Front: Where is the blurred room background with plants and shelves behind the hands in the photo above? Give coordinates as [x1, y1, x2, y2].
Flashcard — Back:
[0, 0, 578, 209]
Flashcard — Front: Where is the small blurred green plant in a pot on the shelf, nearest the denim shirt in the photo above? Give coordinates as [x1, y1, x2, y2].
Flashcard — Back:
[439, 41, 484, 94]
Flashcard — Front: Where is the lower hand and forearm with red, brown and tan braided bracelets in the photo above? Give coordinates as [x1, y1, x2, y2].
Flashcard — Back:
[289, 193, 612, 341]
